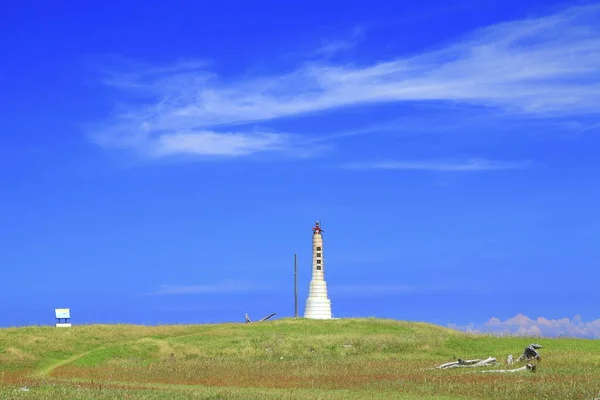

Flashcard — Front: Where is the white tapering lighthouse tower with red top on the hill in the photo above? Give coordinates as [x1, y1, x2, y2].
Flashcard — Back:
[304, 221, 331, 319]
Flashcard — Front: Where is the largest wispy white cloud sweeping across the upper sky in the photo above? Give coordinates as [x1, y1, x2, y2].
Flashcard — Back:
[93, 5, 600, 157]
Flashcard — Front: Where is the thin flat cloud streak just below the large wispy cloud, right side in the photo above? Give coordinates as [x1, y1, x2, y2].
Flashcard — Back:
[341, 159, 531, 172]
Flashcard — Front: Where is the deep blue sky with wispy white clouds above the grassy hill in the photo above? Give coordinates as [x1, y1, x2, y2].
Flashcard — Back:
[0, 0, 600, 336]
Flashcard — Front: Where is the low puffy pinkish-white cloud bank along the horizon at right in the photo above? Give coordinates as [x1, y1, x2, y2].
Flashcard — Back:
[448, 314, 600, 338]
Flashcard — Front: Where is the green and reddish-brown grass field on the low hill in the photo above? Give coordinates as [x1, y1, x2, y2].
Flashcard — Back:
[0, 319, 600, 400]
